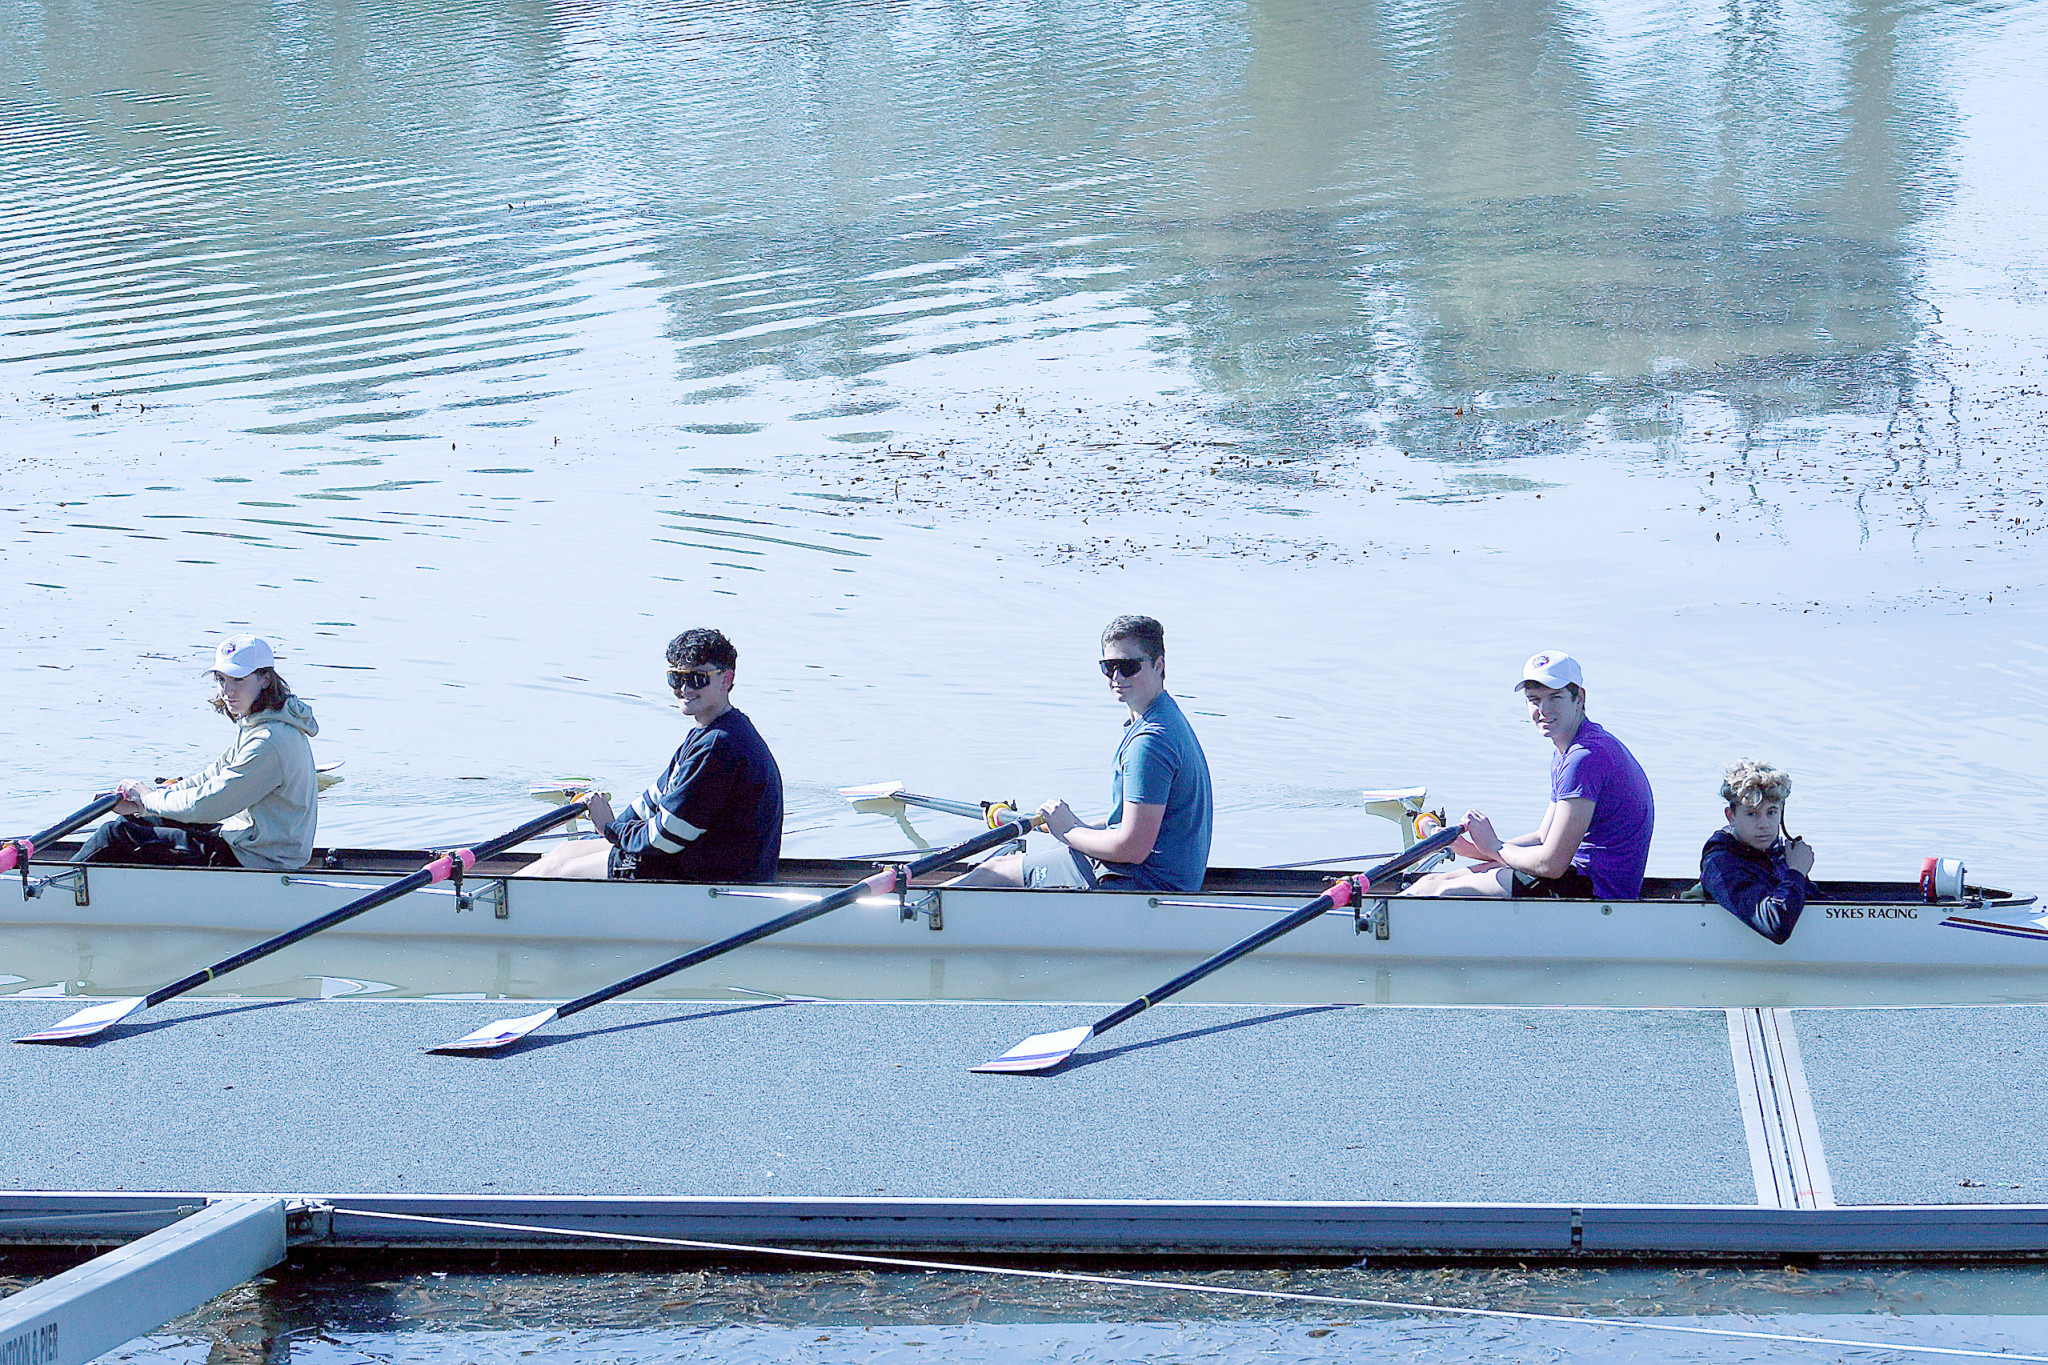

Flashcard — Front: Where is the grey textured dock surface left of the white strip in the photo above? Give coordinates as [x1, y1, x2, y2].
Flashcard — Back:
[0, 999, 1761, 1203]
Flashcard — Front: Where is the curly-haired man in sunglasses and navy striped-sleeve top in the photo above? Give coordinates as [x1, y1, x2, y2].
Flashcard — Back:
[526, 628, 782, 882]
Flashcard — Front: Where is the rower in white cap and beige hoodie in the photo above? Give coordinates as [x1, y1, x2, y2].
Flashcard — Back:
[72, 634, 319, 872]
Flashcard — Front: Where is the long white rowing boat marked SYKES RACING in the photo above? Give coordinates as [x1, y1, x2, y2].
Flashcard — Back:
[0, 845, 2048, 970]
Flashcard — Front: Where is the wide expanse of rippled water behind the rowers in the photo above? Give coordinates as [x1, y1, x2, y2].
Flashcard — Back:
[0, 0, 2048, 1002]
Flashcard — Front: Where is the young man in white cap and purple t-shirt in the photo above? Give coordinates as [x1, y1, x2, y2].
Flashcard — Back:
[1405, 649, 1657, 900]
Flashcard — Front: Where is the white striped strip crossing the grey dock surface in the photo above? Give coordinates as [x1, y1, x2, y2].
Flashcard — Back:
[1729, 1009, 1835, 1209]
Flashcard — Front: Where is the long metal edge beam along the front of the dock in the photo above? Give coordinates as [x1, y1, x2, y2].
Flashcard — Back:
[12, 1193, 2048, 1259]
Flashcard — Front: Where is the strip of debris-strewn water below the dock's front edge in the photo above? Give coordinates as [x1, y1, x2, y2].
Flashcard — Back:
[48, 1267, 2048, 1365]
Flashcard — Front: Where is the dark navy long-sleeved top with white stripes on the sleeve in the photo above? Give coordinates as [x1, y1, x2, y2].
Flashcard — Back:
[604, 710, 782, 882]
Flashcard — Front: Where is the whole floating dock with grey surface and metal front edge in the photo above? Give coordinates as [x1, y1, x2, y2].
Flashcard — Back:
[0, 999, 2048, 1254]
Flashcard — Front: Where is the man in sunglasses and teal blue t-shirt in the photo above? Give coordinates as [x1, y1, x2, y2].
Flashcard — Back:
[956, 616, 1214, 890]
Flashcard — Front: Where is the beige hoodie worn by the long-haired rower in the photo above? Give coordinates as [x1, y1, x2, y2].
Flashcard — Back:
[141, 698, 319, 872]
